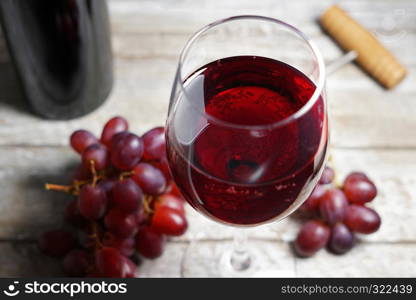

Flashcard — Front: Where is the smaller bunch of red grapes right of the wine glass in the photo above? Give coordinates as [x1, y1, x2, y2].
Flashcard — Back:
[294, 166, 381, 257]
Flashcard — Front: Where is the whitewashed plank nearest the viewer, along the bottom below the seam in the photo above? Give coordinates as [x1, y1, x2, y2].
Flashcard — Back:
[150, 240, 416, 277]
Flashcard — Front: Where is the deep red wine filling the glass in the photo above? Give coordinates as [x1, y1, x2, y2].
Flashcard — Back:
[167, 56, 327, 225]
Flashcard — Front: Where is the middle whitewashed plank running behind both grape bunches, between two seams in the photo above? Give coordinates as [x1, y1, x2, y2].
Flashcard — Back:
[0, 147, 416, 242]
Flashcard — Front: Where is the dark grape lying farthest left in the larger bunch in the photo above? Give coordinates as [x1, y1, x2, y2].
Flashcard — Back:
[38, 230, 76, 257]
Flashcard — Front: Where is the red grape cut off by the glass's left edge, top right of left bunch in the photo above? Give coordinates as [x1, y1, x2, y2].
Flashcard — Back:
[143, 127, 166, 160]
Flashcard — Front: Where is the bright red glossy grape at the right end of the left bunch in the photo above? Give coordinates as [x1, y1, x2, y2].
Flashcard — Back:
[152, 207, 188, 236]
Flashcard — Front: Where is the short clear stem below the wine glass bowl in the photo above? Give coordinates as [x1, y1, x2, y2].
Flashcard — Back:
[230, 229, 251, 271]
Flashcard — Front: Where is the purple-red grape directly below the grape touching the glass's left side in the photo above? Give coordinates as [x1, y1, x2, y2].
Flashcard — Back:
[132, 163, 166, 196]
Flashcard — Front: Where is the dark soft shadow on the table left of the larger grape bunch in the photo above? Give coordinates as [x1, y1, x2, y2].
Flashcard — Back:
[0, 161, 81, 277]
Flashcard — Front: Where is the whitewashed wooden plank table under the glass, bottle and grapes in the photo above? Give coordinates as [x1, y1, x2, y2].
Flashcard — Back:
[0, 0, 416, 277]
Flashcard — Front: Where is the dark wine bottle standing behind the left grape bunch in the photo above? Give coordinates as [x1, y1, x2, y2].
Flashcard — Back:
[0, 0, 113, 119]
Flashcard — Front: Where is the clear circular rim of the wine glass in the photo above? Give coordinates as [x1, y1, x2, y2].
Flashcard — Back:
[177, 15, 325, 130]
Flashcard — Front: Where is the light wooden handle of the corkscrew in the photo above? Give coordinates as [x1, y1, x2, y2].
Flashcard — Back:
[320, 5, 406, 89]
